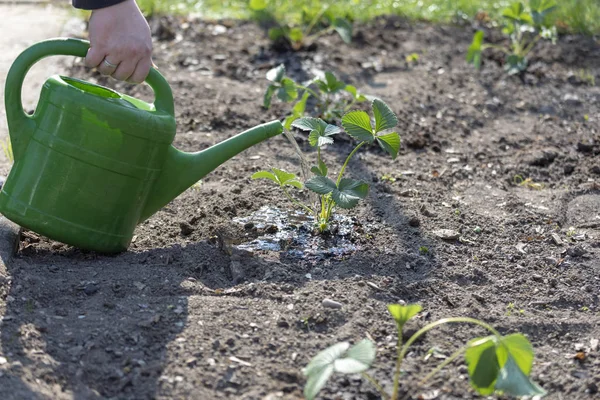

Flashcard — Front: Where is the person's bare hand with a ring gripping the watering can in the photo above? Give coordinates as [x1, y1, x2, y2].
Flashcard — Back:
[85, 0, 152, 83]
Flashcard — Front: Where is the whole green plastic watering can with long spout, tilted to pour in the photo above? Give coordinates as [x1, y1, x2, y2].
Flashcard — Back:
[0, 39, 283, 253]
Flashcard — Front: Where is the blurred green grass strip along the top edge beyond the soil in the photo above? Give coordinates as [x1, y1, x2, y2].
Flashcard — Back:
[138, 0, 600, 34]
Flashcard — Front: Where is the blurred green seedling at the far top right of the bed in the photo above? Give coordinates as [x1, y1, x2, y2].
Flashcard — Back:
[467, 0, 558, 75]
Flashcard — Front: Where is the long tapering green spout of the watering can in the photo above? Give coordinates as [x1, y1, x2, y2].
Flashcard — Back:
[139, 121, 283, 222]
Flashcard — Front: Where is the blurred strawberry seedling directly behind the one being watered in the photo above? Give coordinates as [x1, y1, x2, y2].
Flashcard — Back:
[263, 64, 368, 125]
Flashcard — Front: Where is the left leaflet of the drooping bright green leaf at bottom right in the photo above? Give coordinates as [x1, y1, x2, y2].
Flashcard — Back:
[465, 336, 500, 395]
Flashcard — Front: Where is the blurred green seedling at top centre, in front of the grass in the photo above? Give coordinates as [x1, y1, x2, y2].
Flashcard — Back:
[249, 0, 352, 50]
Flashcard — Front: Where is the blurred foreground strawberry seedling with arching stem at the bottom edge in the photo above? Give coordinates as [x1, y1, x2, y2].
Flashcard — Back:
[303, 304, 546, 400]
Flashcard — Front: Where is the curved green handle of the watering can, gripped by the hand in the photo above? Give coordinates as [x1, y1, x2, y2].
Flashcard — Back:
[5, 38, 175, 120]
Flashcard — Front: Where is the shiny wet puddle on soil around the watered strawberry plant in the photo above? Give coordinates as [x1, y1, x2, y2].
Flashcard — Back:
[233, 206, 359, 259]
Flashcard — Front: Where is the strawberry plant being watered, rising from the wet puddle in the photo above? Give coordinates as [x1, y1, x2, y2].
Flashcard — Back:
[252, 99, 400, 232]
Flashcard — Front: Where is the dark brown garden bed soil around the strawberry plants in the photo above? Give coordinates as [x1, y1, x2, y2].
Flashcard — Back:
[0, 14, 600, 400]
